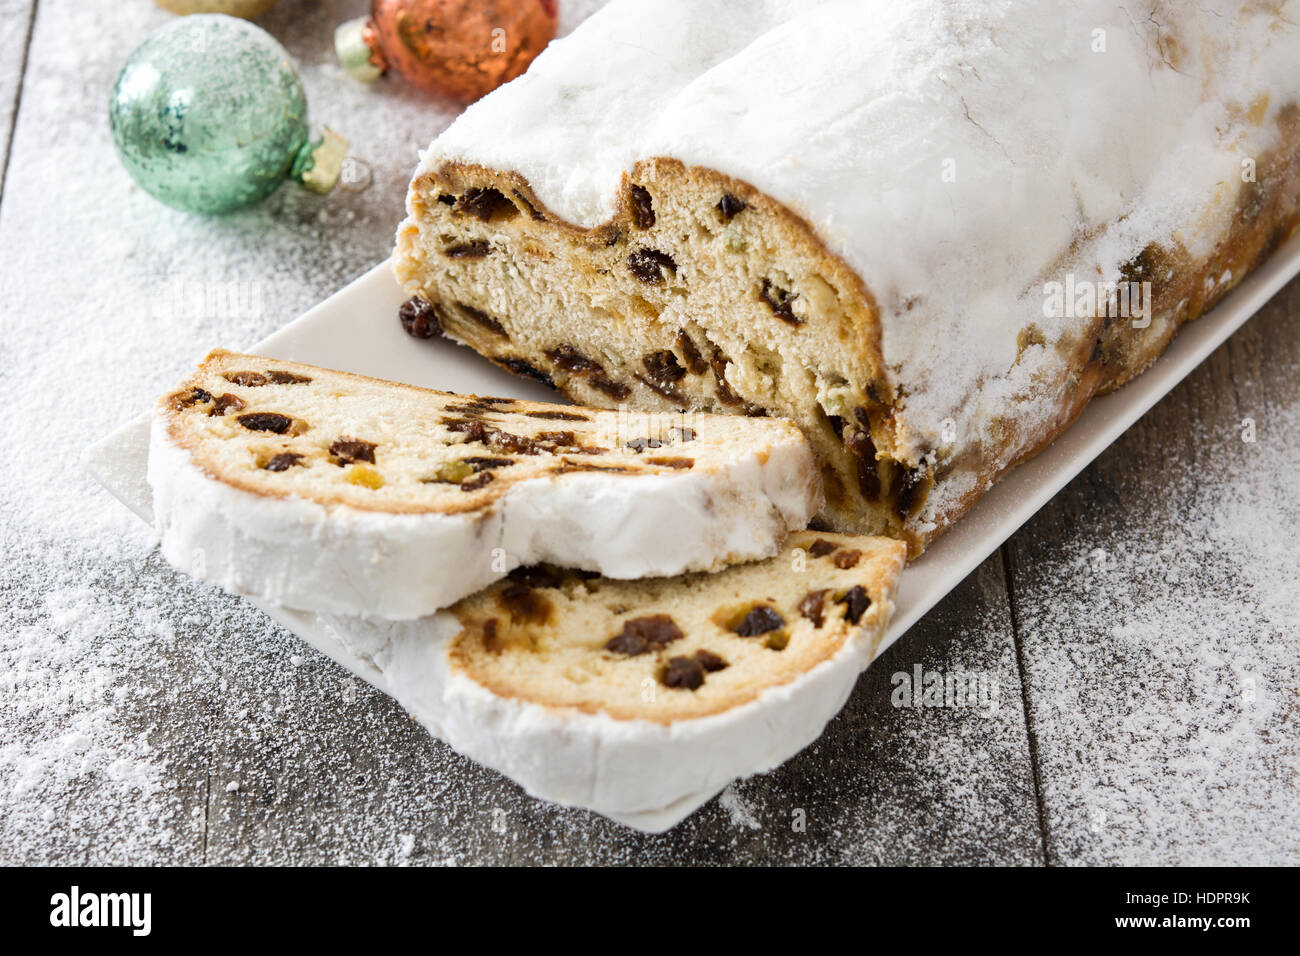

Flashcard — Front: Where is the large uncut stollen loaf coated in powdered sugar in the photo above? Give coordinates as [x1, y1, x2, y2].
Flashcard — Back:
[394, 0, 1300, 553]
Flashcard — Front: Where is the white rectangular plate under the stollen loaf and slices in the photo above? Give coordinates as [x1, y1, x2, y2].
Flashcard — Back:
[86, 235, 1300, 830]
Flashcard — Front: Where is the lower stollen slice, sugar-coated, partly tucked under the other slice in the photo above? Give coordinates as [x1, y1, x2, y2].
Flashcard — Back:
[332, 532, 906, 829]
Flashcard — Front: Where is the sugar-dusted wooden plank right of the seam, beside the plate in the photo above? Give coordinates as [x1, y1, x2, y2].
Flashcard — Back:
[1008, 281, 1300, 864]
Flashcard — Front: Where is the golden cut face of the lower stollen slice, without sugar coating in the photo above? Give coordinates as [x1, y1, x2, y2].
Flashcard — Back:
[447, 532, 906, 724]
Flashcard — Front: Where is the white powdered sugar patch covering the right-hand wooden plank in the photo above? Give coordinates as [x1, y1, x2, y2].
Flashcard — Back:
[1018, 385, 1300, 864]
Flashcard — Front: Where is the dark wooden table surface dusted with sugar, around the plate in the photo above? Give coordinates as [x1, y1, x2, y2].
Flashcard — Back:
[0, 0, 1300, 865]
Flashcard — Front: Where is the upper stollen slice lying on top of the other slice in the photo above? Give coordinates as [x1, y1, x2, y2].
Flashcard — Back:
[148, 351, 820, 619]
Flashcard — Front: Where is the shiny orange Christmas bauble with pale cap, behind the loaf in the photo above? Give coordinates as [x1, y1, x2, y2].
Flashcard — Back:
[334, 0, 558, 103]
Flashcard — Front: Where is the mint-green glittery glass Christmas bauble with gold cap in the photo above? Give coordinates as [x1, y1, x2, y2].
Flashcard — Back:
[109, 14, 347, 213]
